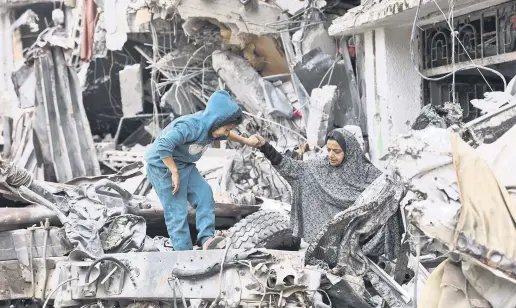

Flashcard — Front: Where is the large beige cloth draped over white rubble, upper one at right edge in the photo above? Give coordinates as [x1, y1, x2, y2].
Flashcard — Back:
[451, 134, 516, 278]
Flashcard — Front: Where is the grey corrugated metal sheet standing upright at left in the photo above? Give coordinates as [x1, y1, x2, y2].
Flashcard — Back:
[33, 47, 100, 183]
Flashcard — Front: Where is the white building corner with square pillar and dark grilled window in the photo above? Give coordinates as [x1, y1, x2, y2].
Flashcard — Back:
[328, 0, 515, 160]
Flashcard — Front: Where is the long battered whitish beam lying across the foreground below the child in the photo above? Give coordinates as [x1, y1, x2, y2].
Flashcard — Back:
[0, 250, 321, 306]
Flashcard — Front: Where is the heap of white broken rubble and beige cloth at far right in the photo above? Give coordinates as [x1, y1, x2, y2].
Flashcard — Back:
[385, 94, 516, 307]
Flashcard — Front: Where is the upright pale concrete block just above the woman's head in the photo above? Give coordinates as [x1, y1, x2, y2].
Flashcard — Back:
[306, 86, 338, 147]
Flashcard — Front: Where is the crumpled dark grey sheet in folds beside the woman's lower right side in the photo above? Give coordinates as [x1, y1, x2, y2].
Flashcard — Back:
[306, 174, 405, 276]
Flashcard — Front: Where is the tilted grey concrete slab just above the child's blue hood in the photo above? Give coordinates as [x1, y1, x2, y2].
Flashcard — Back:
[212, 50, 267, 114]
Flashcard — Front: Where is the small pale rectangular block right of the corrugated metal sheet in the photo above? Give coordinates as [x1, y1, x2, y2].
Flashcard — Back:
[119, 64, 143, 116]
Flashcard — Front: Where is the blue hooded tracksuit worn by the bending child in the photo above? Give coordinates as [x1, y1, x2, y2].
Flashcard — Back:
[145, 91, 242, 250]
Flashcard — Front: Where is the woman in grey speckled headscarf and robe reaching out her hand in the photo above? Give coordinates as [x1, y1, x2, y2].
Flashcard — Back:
[259, 128, 382, 243]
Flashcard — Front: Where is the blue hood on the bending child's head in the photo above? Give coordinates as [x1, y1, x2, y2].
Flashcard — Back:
[199, 90, 242, 135]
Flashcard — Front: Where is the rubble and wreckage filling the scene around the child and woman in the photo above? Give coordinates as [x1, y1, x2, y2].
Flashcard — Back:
[0, 0, 516, 308]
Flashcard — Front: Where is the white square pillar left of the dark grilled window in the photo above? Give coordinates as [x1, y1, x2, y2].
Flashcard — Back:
[364, 27, 422, 162]
